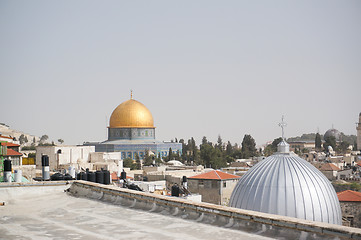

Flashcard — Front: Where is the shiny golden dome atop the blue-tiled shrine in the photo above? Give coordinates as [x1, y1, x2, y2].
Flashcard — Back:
[109, 99, 154, 128]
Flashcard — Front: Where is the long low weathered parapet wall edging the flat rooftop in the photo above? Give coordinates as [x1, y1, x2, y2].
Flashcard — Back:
[69, 181, 361, 239]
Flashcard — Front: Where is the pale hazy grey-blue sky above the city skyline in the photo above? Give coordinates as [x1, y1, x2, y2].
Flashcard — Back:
[0, 0, 361, 145]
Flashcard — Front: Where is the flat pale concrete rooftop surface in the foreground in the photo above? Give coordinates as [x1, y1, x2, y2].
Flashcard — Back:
[0, 184, 270, 240]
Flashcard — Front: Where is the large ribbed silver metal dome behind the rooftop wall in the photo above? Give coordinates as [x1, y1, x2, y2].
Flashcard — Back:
[229, 141, 342, 225]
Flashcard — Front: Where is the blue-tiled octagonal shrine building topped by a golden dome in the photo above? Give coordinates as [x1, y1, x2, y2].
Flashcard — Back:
[86, 95, 182, 159]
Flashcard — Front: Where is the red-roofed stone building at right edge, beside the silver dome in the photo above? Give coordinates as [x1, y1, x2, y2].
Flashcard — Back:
[337, 190, 361, 228]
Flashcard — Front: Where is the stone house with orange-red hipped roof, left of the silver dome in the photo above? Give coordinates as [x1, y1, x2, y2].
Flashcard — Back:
[188, 170, 240, 205]
